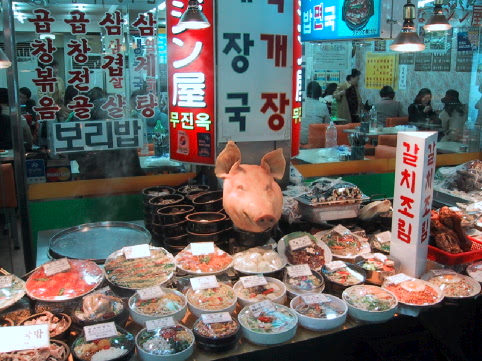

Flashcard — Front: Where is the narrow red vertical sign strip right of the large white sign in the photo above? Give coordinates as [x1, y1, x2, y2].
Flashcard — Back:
[291, 0, 303, 157]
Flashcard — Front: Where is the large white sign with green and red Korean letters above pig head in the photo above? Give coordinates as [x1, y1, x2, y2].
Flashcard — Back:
[217, 0, 294, 142]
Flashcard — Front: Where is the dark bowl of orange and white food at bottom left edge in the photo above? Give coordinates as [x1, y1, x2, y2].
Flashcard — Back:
[71, 327, 135, 361]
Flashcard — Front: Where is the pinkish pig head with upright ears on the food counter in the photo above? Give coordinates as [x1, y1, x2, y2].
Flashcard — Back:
[215, 141, 286, 232]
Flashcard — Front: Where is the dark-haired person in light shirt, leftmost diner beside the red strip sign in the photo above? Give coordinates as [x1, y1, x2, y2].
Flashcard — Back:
[300, 81, 330, 145]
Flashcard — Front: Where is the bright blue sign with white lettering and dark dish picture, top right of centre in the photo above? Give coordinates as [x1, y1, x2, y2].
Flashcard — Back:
[301, 0, 381, 41]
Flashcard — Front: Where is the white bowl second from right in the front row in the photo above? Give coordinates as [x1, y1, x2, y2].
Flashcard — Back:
[290, 293, 348, 331]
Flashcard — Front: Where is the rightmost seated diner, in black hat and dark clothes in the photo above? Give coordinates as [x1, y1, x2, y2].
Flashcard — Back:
[439, 89, 468, 142]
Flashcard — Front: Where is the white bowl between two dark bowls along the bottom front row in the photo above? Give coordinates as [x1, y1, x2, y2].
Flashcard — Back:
[136, 325, 194, 361]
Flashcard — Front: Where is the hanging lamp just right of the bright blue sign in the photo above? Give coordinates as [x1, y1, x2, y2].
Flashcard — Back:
[390, 0, 425, 53]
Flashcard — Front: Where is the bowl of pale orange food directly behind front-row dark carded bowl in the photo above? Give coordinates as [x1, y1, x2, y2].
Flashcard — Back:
[186, 283, 238, 317]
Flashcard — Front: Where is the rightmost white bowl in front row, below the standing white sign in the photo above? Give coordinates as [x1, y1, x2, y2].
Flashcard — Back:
[342, 285, 398, 323]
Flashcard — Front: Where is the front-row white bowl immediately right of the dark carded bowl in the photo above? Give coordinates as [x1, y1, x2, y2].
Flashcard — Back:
[238, 303, 298, 345]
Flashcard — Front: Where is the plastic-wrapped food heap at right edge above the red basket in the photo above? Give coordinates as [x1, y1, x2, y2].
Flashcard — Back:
[434, 159, 482, 200]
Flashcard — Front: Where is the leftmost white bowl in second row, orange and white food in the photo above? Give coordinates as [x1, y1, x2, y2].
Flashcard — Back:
[129, 287, 187, 326]
